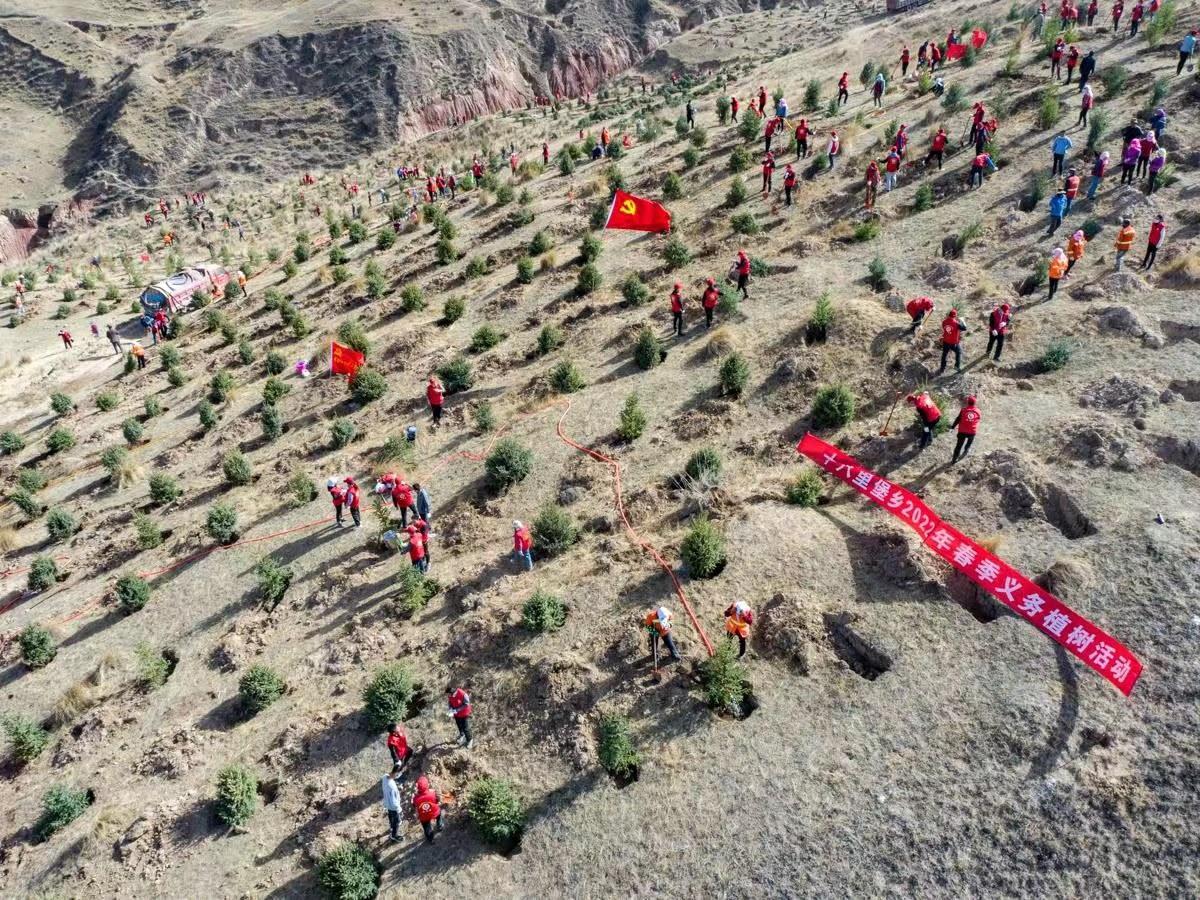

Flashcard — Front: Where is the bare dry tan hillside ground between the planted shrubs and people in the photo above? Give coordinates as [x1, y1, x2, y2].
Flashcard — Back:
[0, 2, 1200, 898]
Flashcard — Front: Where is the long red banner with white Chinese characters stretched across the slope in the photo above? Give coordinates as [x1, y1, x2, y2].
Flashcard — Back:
[796, 434, 1141, 697]
